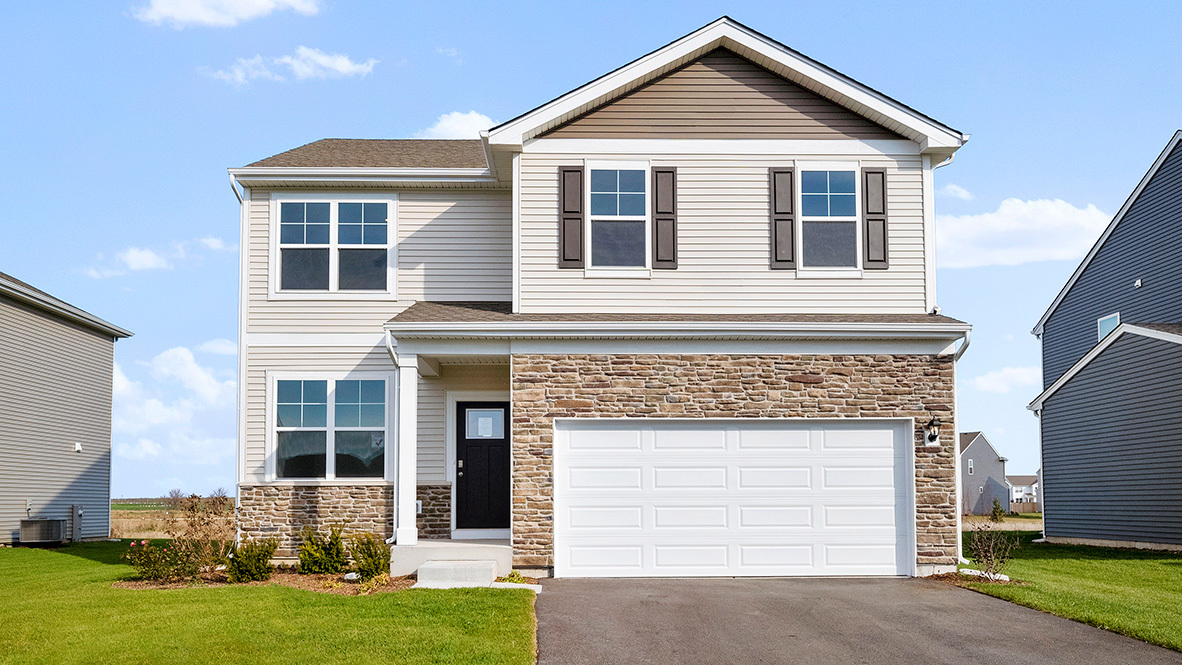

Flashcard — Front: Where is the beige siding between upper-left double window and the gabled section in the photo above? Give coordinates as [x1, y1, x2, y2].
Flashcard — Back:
[398, 190, 513, 300]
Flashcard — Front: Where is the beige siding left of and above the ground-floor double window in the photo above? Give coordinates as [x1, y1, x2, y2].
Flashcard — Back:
[242, 345, 395, 483]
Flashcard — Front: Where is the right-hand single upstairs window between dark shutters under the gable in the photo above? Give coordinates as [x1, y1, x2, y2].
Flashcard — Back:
[800, 169, 858, 269]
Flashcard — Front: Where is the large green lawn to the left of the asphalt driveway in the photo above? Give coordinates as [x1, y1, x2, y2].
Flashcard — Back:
[0, 542, 535, 665]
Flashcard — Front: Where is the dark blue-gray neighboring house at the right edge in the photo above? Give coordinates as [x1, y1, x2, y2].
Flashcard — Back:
[1030, 131, 1182, 549]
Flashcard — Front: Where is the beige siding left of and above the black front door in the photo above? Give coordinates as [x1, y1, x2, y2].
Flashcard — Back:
[418, 365, 509, 483]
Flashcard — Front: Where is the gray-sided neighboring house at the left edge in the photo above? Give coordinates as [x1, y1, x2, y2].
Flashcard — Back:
[0, 273, 131, 545]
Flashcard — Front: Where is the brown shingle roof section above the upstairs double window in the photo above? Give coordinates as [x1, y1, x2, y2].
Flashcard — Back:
[246, 138, 488, 169]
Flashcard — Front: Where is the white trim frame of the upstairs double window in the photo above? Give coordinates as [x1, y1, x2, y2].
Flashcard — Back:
[268, 191, 398, 300]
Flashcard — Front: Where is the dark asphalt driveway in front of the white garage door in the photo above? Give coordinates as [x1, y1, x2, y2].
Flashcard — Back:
[537, 579, 1182, 665]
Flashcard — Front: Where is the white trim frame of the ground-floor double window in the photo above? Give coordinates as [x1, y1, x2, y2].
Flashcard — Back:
[266, 371, 398, 485]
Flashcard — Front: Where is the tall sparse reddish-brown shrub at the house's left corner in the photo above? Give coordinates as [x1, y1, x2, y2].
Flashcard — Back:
[167, 493, 234, 576]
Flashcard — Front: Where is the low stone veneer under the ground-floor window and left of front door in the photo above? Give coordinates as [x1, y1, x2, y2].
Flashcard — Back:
[238, 484, 452, 556]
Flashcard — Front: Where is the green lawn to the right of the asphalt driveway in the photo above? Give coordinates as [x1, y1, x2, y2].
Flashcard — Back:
[965, 533, 1182, 651]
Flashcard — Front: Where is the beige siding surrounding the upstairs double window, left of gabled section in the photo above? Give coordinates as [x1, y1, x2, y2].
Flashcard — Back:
[246, 190, 513, 334]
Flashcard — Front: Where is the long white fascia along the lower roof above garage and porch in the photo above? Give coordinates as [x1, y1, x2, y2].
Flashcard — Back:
[385, 321, 972, 340]
